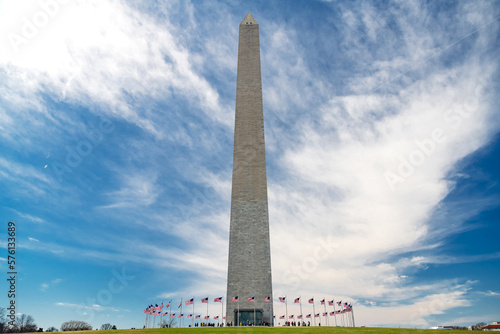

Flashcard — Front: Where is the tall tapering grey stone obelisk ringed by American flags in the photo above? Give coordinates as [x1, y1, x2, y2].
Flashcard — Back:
[226, 13, 273, 326]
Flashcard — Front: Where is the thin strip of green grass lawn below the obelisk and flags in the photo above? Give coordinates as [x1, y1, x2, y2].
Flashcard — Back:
[79, 327, 464, 334]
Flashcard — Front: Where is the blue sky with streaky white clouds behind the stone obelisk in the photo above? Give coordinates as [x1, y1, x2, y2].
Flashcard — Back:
[0, 0, 500, 328]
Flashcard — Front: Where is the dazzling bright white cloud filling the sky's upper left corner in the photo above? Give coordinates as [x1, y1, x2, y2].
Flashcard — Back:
[0, 1, 229, 137]
